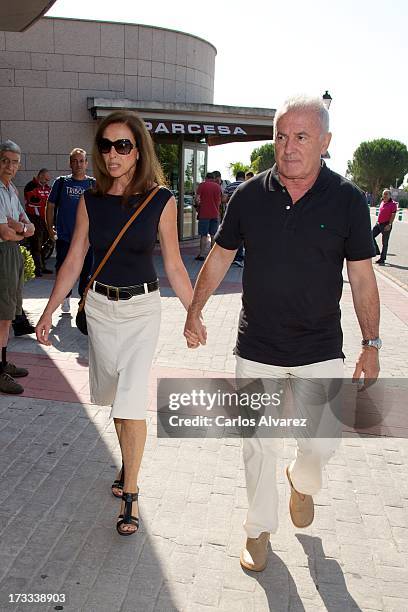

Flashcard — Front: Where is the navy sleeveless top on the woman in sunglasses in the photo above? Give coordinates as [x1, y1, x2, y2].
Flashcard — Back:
[84, 187, 173, 287]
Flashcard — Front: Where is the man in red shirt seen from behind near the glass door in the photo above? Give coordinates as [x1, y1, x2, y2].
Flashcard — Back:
[195, 172, 221, 261]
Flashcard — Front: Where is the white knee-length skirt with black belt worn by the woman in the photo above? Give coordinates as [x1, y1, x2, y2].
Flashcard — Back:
[85, 291, 161, 420]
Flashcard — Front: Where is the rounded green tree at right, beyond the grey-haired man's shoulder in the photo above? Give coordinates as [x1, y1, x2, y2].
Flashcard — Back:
[347, 138, 408, 202]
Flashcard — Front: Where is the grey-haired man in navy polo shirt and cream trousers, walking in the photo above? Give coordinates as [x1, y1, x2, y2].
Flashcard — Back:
[184, 97, 381, 571]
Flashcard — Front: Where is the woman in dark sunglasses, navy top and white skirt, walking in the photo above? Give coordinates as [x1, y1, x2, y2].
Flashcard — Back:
[37, 111, 198, 536]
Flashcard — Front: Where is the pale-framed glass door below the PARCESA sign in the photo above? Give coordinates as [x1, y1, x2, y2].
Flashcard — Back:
[179, 143, 207, 240]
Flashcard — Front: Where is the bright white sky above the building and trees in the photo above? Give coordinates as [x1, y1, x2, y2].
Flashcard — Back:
[47, 0, 408, 178]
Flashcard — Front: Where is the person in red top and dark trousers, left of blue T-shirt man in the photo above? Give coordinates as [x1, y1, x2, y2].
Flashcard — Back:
[24, 168, 52, 276]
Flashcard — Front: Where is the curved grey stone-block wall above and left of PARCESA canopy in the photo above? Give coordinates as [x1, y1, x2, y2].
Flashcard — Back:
[0, 18, 216, 186]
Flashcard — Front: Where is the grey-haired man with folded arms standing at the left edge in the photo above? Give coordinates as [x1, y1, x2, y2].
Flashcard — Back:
[0, 140, 34, 394]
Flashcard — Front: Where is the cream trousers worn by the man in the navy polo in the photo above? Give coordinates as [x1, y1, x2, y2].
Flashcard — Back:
[236, 357, 344, 538]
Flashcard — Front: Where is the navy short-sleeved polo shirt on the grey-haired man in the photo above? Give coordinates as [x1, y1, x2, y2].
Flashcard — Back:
[215, 164, 375, 366]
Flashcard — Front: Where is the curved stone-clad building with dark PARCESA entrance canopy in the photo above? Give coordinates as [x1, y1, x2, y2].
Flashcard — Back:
[0, 17, 274, 239]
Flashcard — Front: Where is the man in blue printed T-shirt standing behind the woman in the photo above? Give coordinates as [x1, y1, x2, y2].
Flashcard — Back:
[46, 147, 95, 313]
